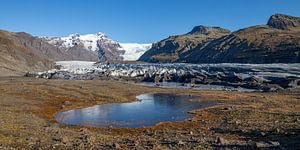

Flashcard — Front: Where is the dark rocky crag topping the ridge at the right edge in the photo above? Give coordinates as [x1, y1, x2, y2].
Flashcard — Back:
[267, 14, 300, 30]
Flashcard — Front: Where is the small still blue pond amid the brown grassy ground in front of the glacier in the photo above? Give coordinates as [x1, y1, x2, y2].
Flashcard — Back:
[56, 94, 216, 128]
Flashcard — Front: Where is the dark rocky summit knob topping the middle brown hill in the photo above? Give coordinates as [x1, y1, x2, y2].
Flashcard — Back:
[187, 25, 230, 35]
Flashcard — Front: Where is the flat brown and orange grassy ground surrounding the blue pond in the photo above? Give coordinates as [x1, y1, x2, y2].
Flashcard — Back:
[0, 77, 300, 149]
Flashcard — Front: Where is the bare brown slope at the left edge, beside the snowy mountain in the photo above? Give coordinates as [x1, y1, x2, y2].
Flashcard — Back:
[0, 30, 56, 76]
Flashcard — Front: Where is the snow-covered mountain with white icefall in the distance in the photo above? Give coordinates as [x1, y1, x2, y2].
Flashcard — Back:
[43, 32, 151, 61]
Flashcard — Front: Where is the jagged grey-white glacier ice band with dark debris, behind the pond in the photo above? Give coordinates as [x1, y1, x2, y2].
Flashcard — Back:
[25, 63, 300, 92]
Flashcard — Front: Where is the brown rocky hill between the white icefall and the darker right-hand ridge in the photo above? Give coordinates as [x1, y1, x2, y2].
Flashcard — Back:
[139, 26, 230, 63]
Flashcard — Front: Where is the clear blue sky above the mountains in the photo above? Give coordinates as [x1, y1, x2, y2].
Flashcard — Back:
[0, 0, 300, 43]
